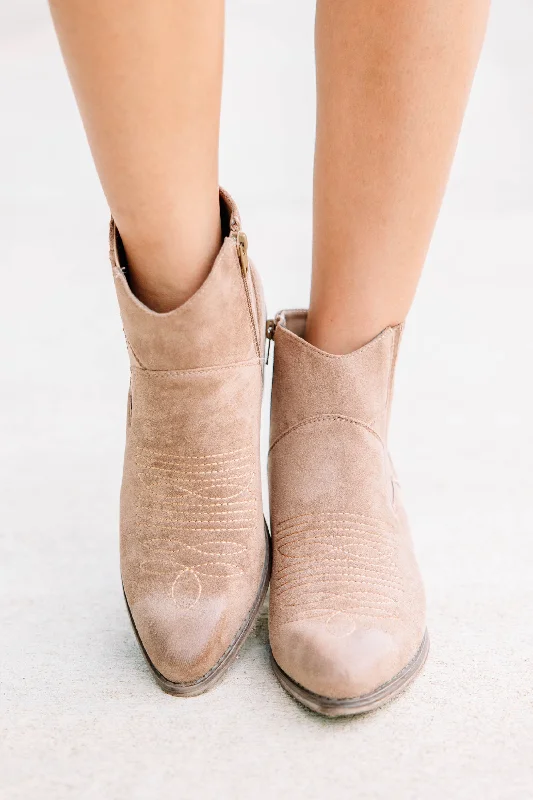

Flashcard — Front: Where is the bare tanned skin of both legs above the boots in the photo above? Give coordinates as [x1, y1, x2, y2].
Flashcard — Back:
[50, 0, 489, 342]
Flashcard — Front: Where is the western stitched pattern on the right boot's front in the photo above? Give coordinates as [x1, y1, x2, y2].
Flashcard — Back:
[273, 511, 404, 635]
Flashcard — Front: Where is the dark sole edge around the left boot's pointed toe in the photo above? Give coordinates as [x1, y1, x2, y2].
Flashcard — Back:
[122, 521, 272, 697]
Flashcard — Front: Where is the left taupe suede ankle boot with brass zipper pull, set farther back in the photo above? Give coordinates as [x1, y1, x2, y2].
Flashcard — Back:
[110, 193, 270, 695]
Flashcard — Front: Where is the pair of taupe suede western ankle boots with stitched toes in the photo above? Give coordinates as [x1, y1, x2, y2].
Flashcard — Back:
[110, 192, 428, 716]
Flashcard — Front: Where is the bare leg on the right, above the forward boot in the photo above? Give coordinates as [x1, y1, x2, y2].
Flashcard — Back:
[306, 0, 489, 354]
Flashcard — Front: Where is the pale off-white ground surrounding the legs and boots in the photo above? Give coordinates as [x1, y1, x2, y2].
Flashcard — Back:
[0, 0, 533, 800]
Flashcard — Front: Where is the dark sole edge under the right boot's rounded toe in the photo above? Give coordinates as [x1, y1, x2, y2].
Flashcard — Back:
[270, 630, 429, 717]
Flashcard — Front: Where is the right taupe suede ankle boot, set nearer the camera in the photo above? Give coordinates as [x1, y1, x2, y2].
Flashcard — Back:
[269, 311, 428, 716]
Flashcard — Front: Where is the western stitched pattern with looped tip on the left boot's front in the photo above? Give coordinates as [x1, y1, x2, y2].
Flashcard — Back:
[136, 446, 257, 608]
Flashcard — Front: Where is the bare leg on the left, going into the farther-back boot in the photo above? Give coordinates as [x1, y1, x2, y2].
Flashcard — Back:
[50, 0, 224, 311]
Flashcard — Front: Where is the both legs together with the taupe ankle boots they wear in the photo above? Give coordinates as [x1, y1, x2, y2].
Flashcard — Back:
[51, 0, 488, 713]
